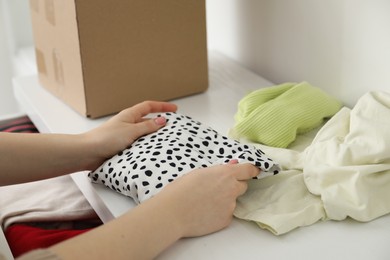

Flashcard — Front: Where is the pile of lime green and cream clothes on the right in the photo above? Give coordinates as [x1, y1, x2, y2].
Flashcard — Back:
[229, 82, 390, 235]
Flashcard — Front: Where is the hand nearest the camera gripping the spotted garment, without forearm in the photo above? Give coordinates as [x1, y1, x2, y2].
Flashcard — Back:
[156, 163, 260, 237]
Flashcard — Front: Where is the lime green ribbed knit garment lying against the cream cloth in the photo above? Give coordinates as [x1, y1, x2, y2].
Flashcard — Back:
[230, 82, 342, 148]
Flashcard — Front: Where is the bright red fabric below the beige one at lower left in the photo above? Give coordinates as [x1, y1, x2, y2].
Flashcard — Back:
[5, 224, 92, 258]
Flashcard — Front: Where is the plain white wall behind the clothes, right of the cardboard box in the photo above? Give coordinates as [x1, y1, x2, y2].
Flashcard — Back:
[207, 0, 390, 106]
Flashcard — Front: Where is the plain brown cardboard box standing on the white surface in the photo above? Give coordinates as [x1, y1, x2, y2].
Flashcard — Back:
[30, 0, 208, 118]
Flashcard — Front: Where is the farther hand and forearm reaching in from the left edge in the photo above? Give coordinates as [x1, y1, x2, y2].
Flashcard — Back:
[0, 101, 177, 185]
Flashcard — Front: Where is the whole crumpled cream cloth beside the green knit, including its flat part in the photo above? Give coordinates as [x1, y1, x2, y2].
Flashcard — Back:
[234, 92, 390, 235]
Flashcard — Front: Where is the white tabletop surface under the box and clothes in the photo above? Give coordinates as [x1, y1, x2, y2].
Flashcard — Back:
[14, 53, 390, 260]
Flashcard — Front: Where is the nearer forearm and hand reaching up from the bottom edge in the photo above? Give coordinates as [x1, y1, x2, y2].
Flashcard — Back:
[50, 163, 259, 259]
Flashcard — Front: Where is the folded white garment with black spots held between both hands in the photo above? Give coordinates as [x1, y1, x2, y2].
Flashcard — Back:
[88, 113, 280, 203]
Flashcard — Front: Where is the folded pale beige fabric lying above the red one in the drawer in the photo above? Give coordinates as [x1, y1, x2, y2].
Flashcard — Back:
[0, 176, 96, 230]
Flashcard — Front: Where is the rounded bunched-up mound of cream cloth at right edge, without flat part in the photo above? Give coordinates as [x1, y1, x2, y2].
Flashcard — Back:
[303, 92, 390, 221]
